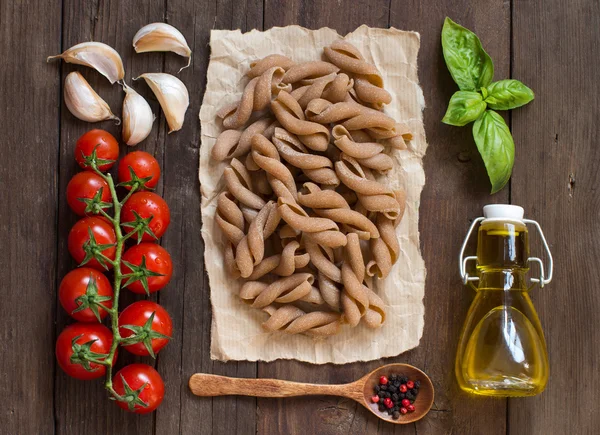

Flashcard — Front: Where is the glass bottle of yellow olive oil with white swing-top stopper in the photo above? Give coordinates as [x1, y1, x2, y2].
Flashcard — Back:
[455, 205, 552, 397]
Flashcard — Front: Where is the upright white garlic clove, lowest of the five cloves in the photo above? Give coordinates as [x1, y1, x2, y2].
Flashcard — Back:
[123, 83, 155, 146]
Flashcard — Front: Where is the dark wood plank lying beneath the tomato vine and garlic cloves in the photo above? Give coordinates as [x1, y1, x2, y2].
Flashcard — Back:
[55, 0, 165, 434]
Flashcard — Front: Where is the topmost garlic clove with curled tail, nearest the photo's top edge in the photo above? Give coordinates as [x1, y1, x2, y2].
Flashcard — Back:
[133, 23, 192, 71]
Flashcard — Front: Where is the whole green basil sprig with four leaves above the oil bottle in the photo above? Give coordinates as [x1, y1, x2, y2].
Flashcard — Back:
[442, 18, 534, 193]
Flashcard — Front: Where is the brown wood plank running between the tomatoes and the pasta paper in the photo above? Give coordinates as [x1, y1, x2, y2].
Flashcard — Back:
[156, 0, 262, 434]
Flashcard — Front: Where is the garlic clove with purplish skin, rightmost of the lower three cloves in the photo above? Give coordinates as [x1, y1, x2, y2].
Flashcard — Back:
[134, 73, 190, 133]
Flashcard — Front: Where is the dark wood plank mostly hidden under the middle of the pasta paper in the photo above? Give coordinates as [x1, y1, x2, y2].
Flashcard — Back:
[258, 0, 389, 434]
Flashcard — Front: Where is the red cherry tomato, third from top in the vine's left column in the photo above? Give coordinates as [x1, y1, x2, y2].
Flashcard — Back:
[68, 216, 117, 270]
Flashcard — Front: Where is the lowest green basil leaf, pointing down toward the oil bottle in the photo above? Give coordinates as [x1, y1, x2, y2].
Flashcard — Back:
[473, 110, 515, 193]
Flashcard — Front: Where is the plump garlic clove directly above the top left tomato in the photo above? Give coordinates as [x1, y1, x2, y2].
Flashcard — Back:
[64, 71, 121, 124]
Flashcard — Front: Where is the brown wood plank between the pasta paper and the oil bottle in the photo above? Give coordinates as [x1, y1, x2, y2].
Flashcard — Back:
[390, 0, 510, 434]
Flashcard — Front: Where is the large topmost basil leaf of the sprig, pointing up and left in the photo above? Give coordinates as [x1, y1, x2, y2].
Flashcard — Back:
[442, 18, 494, 91]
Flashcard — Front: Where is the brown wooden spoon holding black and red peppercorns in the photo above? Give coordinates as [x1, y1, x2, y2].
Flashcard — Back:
[189, 364, 433, 424]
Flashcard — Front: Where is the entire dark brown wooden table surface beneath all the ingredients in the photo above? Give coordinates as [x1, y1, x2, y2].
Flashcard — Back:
[0, 0, 600, 435]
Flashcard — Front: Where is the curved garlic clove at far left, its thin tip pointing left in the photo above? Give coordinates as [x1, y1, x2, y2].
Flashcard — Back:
[46, 42, 125, 84]
